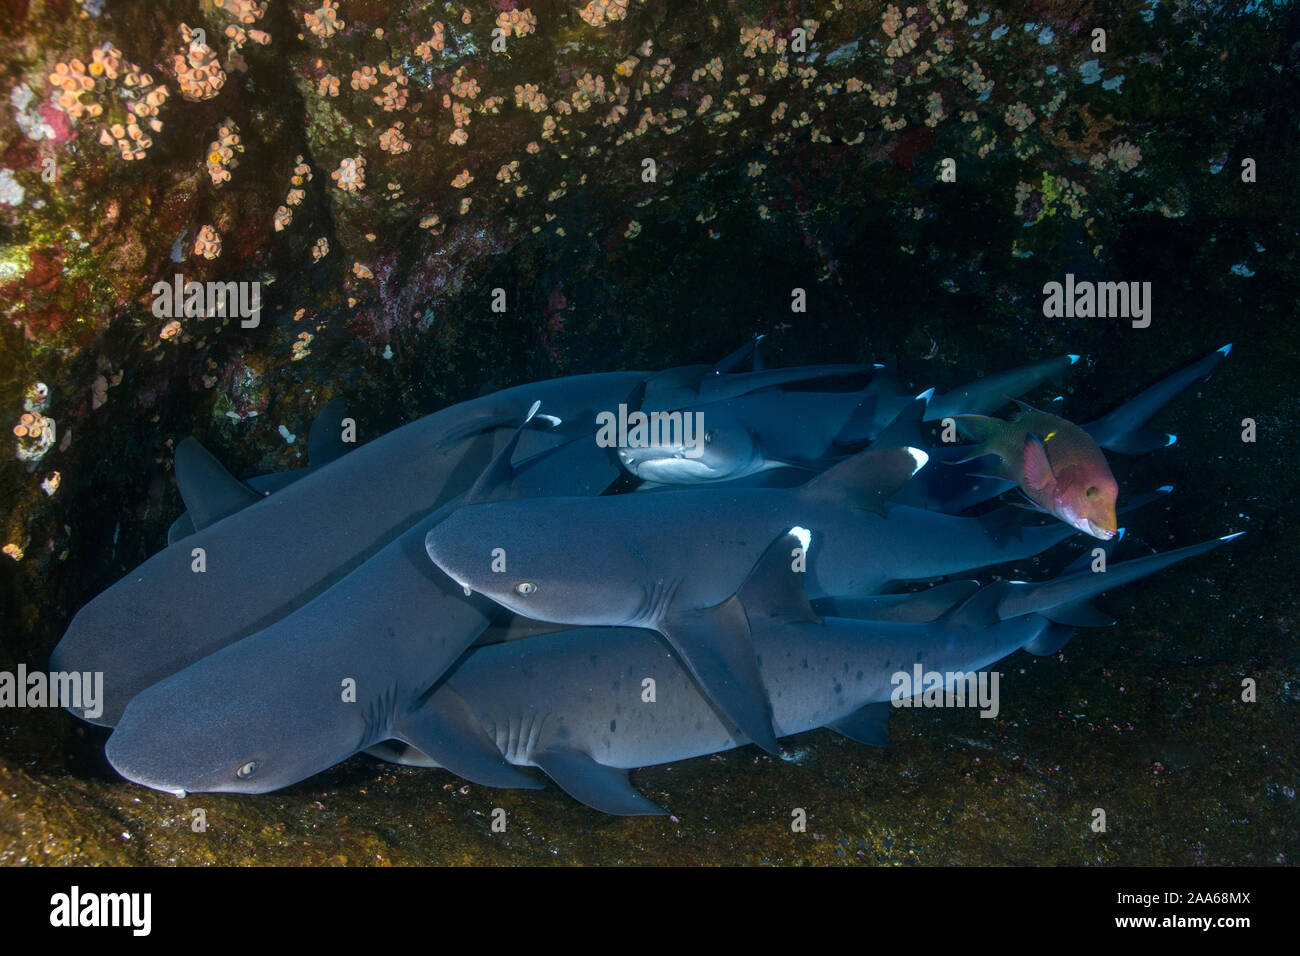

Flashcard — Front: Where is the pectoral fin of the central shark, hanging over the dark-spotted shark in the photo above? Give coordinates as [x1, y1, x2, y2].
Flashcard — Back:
[659, 594, 780, 754]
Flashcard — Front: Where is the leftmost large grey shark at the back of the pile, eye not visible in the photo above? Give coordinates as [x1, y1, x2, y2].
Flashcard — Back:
[49, 365, 867, 726]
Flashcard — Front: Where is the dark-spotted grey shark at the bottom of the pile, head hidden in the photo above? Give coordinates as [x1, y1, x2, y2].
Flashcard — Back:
[364, 538, 1230, 814]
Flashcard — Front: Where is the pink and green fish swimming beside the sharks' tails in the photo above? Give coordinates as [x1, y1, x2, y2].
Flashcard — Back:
[953, 402, 1119, 541]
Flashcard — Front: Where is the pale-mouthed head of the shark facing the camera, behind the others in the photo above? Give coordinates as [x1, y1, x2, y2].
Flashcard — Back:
[619, 411, 762, 485]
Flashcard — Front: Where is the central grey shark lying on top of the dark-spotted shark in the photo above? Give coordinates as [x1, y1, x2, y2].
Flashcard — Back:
[425, 449, 1074, 750]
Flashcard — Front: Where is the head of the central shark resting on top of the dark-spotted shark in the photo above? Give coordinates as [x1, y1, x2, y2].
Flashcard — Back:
[424, 498, 645, 624]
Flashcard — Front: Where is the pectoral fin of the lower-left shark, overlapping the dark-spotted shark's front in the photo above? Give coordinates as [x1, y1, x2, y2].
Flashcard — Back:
[393, 684, 542, 790]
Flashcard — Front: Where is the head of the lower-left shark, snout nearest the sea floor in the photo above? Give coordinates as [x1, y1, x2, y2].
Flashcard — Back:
[105, 631, 384, 793]
